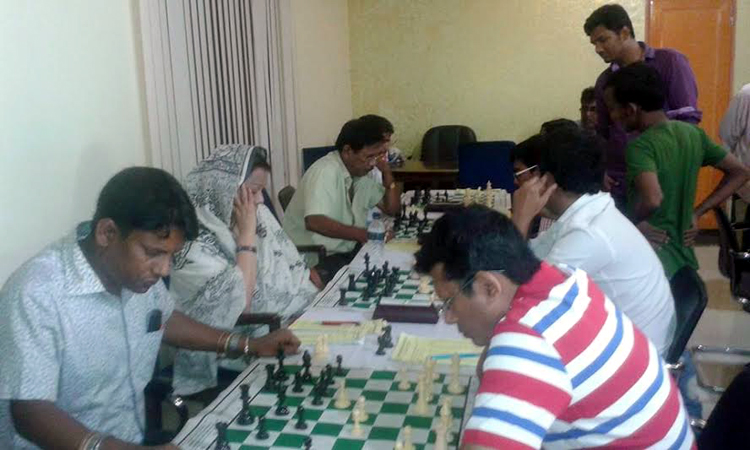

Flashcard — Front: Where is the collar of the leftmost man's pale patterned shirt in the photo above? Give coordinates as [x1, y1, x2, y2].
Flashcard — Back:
[62, 221, 106, 295]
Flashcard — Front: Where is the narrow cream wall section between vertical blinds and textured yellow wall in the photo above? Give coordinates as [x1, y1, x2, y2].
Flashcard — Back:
[292, 0, 352, 154]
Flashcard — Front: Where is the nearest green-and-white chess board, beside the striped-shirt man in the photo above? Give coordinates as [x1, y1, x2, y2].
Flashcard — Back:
[210, 365, 477, 450]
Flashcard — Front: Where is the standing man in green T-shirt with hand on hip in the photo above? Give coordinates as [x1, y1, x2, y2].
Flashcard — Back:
[604, 63, 748, 279]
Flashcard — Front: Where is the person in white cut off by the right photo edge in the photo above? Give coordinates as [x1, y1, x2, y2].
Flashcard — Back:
[719, 84, 750, 203]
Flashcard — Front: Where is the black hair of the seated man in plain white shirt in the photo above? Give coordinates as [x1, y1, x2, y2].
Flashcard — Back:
[539, 128, 604, 194]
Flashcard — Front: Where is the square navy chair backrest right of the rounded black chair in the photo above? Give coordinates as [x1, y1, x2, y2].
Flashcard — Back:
[458, 141, 516, 192]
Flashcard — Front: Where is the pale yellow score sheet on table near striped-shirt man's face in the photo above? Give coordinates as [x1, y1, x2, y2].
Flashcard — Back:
[391, 333, 483, 366]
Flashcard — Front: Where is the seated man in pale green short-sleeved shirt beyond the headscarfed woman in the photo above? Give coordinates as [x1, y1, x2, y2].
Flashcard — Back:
[284, 115, 401, 283]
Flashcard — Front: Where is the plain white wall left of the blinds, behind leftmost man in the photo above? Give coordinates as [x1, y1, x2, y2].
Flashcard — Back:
[0, 0, 148, 283]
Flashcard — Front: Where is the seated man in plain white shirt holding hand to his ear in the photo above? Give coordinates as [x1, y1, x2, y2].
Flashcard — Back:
[513, 128, 676, 356]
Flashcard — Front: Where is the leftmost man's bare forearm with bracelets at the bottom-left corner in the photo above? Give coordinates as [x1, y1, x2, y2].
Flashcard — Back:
[10, 400, 145, 450]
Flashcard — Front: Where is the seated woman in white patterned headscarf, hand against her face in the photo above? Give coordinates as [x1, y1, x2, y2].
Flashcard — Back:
[170, 145, 320, 395]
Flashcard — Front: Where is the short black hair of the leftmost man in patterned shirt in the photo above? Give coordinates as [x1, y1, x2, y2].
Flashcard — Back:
[93, 167, 198, 241]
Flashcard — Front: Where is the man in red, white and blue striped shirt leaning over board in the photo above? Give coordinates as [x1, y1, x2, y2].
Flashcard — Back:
[416, 206, 695, 450]
